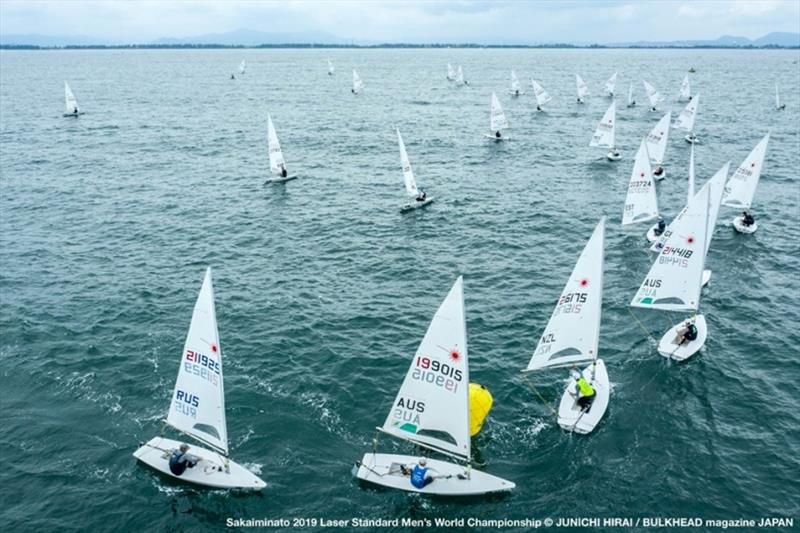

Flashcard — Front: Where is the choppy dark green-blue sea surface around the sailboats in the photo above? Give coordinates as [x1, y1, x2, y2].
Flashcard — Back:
[0, 49, 800, 531]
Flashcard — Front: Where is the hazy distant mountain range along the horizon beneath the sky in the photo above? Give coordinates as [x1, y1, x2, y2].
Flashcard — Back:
[0, 29, 800, 48]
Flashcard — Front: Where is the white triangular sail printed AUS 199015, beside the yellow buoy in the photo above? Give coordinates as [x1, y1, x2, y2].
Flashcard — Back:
[383, 277, 470, 459]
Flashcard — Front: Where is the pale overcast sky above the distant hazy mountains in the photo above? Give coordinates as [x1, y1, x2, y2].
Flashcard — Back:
[0, 0, 800, 43]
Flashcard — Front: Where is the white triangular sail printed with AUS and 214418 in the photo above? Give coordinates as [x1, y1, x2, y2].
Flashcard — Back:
[630, 186, 711, 311]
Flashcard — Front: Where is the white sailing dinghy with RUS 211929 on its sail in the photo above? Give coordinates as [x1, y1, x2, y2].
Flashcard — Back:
[133, 268, 266, 490]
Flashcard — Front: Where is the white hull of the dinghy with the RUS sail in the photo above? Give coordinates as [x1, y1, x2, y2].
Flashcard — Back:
[133, 437, 267, 490]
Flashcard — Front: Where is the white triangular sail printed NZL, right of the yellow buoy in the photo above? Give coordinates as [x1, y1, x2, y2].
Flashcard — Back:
[525, 217, 605, 371]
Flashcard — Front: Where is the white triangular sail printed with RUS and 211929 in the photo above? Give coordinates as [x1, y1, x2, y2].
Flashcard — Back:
[167, 268, 228, 455]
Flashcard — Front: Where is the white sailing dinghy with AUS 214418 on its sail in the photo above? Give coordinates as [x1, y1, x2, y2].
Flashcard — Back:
[630, 178, 724, 361]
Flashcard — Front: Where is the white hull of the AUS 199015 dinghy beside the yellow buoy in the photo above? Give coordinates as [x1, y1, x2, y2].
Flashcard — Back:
[356, 453, 516, 496]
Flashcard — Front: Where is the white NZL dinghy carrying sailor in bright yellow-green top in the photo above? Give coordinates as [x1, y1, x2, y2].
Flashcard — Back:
[523, 218, 611, 434]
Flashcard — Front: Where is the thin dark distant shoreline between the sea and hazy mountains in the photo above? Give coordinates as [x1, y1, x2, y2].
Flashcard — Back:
[0, 43, 800, 50]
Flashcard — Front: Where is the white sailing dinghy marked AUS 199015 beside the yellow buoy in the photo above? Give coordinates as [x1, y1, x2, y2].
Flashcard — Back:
[355, 277, 515, 496]
